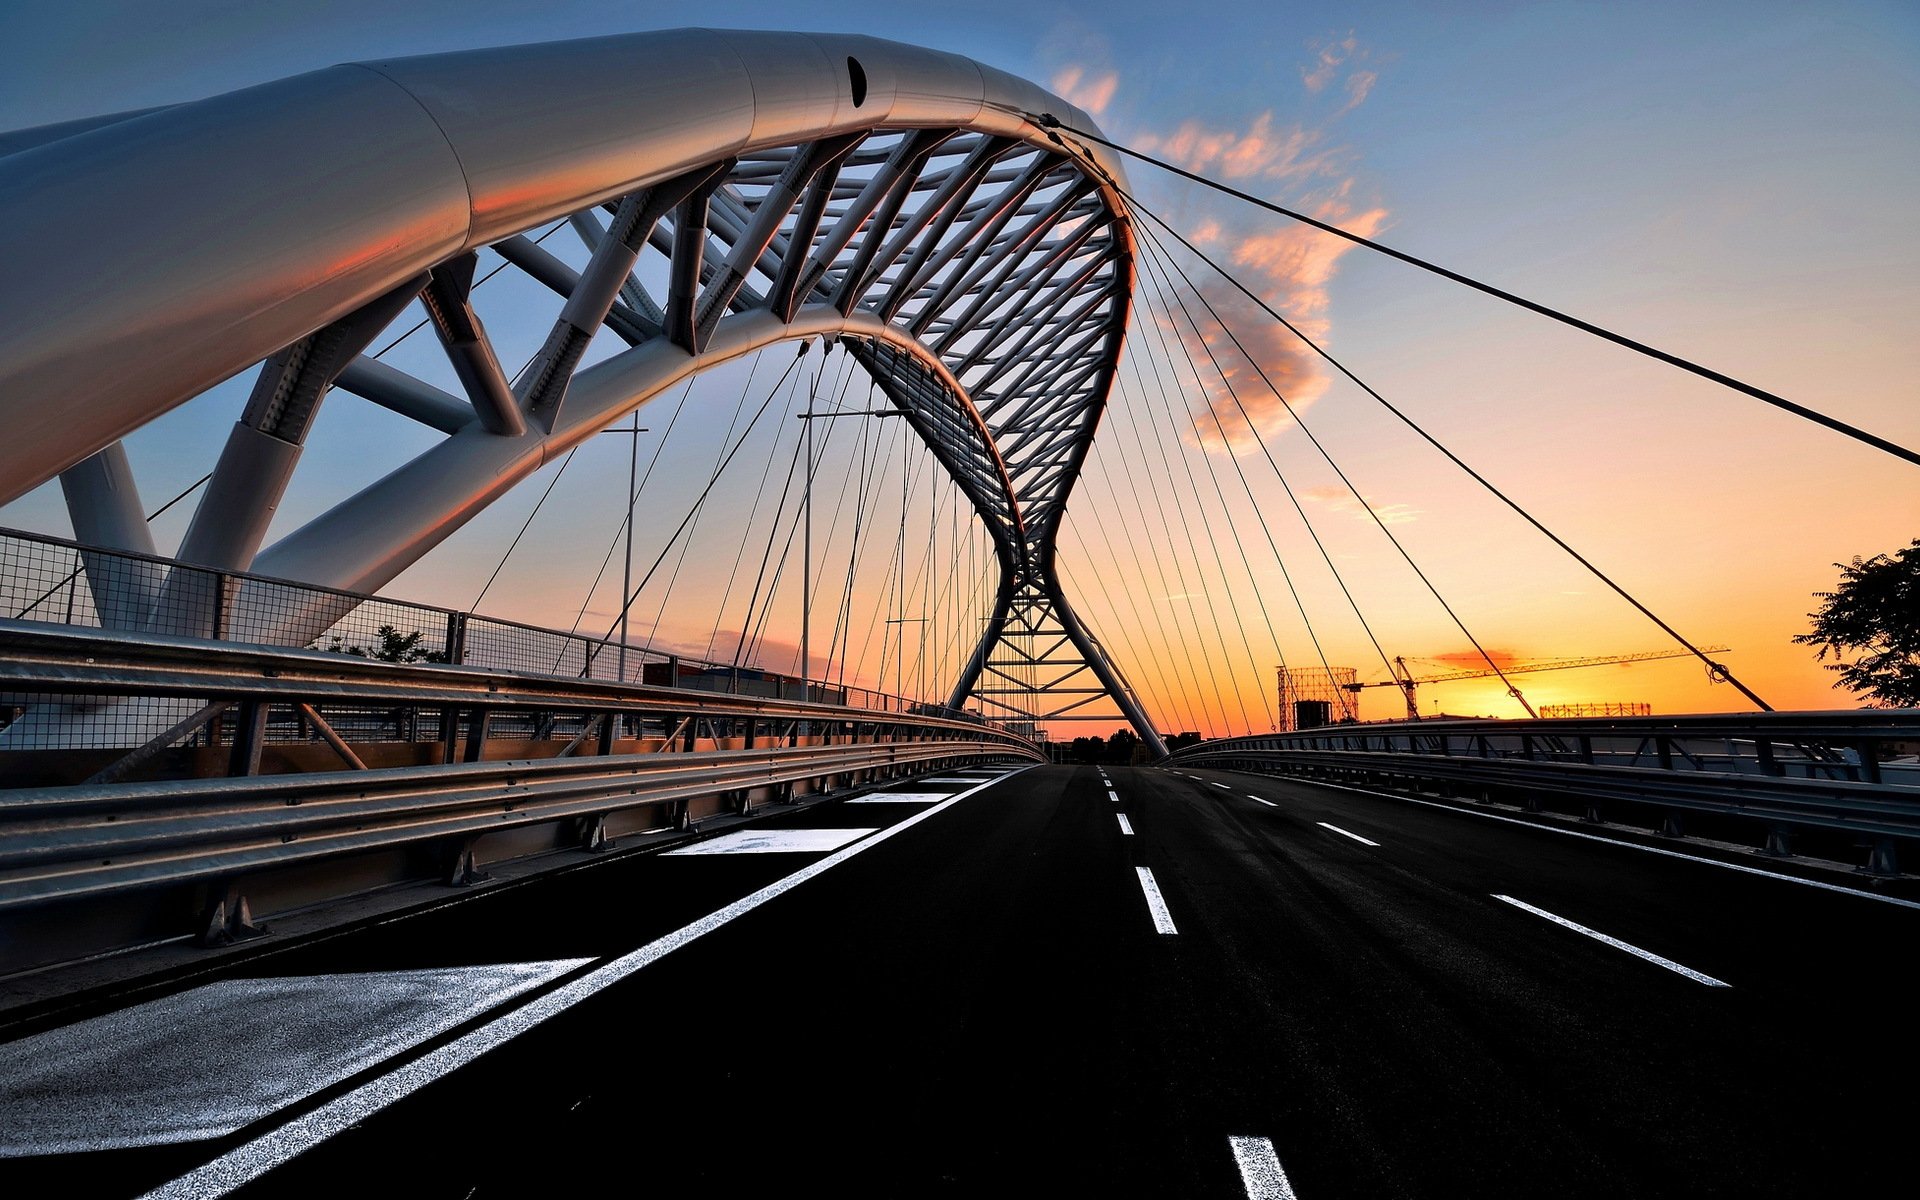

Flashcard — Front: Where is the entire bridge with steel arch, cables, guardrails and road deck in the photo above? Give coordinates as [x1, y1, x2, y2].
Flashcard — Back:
[0, 31, 1920, 1200]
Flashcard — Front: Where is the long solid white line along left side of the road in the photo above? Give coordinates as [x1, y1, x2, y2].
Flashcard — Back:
[142, 768, 1025, 1200]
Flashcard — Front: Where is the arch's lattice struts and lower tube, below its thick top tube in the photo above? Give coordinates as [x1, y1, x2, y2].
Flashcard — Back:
[33, 117, 1158, 743]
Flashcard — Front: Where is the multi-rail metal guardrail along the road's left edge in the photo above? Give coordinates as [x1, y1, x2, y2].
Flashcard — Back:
[0, 620, 1043, 970]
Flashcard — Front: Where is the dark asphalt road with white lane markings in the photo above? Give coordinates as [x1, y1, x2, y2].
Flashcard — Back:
[0, 766, 1920, 1200]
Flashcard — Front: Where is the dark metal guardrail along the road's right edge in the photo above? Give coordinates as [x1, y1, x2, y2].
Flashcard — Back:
[1169, 708, 1920, 874]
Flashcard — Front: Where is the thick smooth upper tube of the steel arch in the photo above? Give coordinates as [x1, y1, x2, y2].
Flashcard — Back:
[0, 29, 1123, 503]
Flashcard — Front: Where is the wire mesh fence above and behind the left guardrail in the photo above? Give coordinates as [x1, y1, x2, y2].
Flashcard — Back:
[0, 530, 979, 733]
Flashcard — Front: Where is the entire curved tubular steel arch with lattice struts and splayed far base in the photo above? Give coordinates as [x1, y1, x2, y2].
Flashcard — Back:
[0, 29, 1160, 749]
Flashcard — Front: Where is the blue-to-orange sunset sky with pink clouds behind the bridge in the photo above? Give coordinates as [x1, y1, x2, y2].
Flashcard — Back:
[0, 0, 1920, 735]
